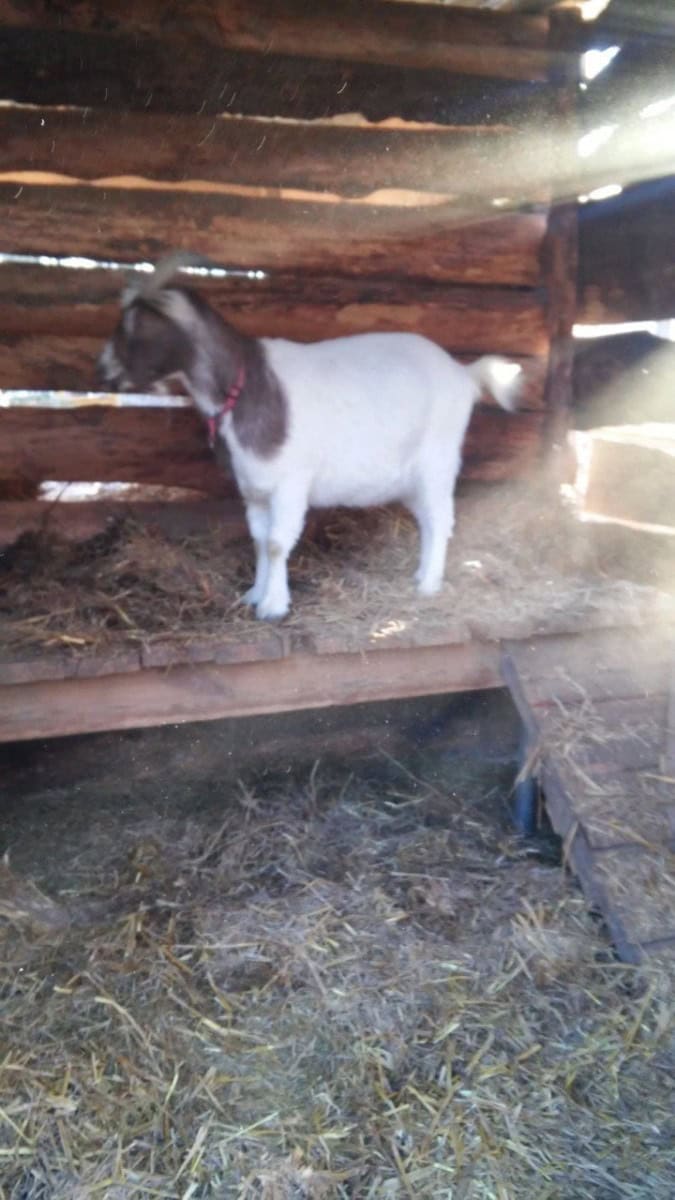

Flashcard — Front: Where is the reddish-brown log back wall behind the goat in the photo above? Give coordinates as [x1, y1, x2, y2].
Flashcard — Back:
[0, 0, 573, 535]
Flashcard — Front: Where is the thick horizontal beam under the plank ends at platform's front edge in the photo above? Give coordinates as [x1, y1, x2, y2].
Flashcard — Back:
[0, 642, 500, 742]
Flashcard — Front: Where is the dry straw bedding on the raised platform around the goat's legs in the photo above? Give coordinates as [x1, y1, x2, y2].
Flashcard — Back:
[0, 484, 675, 654]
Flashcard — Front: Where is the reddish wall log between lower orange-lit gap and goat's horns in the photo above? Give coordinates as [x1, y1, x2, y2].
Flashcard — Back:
[0, 184, 545, 287]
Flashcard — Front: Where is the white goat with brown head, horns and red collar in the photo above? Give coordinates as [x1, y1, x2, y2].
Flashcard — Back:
[98, 254, 520, 619]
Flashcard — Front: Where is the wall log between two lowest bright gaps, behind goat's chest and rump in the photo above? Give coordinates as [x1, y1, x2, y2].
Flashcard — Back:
[0, 404, 543, 496]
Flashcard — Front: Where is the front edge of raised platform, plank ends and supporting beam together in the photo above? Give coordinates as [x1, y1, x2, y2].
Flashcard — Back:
[0, 626, 502, 742]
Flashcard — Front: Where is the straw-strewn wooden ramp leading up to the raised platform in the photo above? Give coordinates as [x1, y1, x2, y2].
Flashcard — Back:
[502, 628, 675, 962]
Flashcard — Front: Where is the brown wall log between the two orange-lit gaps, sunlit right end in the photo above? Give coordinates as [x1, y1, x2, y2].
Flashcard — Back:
[0, 106, 552, 208]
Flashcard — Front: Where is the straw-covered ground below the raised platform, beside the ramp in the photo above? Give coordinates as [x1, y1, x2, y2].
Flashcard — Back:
[0, 694, 675, 1200]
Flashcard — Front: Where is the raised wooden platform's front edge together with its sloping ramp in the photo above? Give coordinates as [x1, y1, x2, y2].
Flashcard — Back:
[0, 622, 675, 962]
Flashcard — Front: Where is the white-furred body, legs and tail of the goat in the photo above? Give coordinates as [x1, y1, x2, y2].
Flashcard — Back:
[218, 334, 519, 619]
